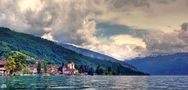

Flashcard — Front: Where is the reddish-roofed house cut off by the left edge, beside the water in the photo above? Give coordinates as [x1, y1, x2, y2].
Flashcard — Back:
[0, 60, 9, 76]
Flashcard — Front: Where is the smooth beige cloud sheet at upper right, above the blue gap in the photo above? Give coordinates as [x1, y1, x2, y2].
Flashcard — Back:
[87, 0, 188, 33]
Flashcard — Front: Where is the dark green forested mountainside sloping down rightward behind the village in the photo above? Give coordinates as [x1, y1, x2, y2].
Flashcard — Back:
[0, 27, 144, 75]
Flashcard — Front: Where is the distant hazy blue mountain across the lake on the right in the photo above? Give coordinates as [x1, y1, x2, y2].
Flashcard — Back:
[125, 53, 188, 75]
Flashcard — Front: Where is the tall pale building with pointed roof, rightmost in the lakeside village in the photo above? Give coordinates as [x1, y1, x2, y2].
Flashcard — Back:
[62, 61, 78, 75]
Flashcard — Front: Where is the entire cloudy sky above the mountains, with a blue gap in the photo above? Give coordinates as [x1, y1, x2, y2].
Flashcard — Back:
[0, 0, 188, 60]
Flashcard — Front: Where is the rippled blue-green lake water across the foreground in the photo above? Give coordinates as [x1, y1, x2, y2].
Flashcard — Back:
[0, 76, 188, 90]
